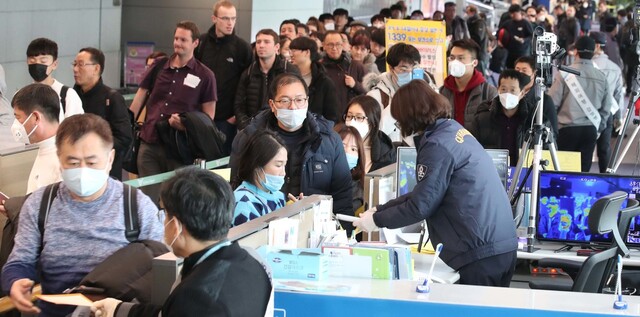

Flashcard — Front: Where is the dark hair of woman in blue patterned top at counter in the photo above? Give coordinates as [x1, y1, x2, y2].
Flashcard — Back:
[233, 129, 287, 188]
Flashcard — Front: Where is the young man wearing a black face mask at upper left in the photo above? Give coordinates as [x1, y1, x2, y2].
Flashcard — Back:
[27, 37, 84, 122]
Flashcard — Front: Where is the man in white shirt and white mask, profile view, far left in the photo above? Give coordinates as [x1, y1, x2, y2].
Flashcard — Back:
[11, 84, 62, 194]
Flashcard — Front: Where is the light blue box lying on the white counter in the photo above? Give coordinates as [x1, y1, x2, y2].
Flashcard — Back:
[266, 249, 329, 281]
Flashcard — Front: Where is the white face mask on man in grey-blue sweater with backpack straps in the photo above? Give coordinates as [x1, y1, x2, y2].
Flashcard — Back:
[62, 164, 109, 197]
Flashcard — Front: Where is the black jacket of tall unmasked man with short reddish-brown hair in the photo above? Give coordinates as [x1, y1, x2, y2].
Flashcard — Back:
[194, 24, 253, 120]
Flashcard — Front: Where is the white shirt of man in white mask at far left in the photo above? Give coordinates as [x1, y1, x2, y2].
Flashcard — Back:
[27, 136, 62, 194]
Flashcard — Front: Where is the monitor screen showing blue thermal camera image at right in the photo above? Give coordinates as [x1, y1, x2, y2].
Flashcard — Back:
[536, 171, 640, 244]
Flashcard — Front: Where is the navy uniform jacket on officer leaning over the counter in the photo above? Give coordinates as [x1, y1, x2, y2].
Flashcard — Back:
[373, 119, 518, 270]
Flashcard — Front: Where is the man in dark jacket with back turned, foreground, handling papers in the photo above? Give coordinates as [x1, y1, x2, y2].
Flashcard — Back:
[91, 166, 273, 317]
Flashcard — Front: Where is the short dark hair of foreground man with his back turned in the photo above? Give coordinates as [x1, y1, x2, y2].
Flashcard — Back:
[161, 165, 235, 241]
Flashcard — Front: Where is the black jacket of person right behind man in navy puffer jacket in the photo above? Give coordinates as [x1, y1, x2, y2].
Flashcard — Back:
[309, 63, 340, 122]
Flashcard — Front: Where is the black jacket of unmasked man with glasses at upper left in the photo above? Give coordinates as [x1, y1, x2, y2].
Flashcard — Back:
[73, 78, 133, 179]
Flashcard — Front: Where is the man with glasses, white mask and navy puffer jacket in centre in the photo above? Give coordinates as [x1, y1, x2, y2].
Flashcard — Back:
[229, 73, 353, 230]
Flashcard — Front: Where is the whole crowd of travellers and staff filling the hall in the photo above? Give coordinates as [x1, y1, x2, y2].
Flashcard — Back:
[0, 0, 638, 316]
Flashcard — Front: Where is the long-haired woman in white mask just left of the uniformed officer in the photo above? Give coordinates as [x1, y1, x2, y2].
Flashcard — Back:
[342, 96, 396, 173]
